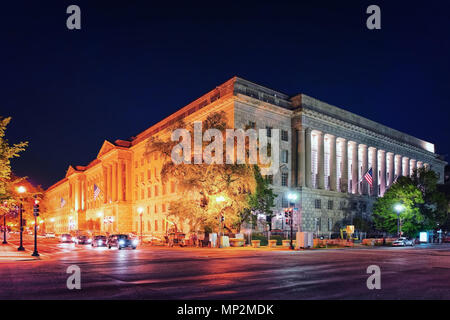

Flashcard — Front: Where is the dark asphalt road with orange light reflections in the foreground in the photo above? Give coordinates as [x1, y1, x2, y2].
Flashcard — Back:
[0, 236, 450, 299]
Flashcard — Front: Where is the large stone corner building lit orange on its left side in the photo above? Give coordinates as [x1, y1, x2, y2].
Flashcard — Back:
[46, 77, 446, 235]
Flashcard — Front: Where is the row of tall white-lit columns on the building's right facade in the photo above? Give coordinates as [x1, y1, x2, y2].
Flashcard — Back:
[296, 128, 428, 196]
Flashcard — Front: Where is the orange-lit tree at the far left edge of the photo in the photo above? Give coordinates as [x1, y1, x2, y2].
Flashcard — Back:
[0, 117, 28, 198]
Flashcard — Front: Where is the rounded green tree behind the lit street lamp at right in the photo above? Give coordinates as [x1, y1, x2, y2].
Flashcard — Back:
[373, 177, 425, 236]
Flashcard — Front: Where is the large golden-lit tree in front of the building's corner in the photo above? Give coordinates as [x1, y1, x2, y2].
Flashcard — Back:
[146, 112, 273, 234]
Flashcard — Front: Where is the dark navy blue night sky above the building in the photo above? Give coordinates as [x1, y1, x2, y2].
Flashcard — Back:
[0, 0, 450, 187]
